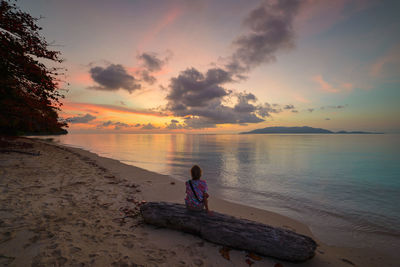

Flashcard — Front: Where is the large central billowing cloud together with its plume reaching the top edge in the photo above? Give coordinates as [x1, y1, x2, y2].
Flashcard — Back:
[162, 0, 300, 129]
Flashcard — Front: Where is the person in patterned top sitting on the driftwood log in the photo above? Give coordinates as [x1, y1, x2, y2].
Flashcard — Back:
[185, 165, 210, 213]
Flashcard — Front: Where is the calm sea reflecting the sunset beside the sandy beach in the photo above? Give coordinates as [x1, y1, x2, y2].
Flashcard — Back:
[46, 134, 400, 253]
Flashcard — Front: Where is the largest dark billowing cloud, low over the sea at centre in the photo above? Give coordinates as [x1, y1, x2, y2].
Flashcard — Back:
[167, 68, 281, 129]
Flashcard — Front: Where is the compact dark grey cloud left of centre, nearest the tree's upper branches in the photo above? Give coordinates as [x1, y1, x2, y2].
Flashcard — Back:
[89, 64, 141, 93]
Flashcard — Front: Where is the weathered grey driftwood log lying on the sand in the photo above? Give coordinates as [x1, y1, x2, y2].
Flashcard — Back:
[140, 202, 317, 262]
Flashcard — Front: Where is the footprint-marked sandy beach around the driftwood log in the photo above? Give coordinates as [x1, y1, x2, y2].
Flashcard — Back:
[0, 138, 399, 266]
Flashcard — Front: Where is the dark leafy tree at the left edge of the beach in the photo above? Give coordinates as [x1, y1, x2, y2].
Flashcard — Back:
[0, 0, 67, 135]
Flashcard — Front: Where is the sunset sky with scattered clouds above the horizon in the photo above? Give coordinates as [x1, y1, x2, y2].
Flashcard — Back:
[17, 0, 400, 133]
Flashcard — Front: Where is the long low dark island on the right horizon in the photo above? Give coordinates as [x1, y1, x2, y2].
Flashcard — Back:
[240, 126, 383, 134]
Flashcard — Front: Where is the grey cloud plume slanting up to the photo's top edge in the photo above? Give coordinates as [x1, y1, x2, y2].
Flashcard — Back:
[226, 0, 301, 73]
